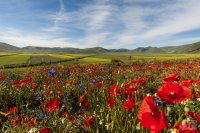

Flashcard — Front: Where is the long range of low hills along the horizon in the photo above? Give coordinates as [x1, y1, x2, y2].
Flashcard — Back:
[0, 42, 200, 54]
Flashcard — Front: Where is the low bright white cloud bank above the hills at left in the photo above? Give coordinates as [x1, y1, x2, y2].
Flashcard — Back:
[0, 28, 79, 47]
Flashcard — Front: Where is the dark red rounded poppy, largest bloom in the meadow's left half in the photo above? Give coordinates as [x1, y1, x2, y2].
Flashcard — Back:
[45, 98, 60, 112]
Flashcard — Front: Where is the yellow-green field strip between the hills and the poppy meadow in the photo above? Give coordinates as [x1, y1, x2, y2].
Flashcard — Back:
[0, 53, 200, 66]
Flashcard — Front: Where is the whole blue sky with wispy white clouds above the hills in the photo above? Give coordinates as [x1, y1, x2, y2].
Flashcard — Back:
[0, 0, 200, 49]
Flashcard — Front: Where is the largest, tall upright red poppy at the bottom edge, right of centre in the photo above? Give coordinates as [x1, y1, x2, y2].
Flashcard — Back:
[138, 96, 168, 133]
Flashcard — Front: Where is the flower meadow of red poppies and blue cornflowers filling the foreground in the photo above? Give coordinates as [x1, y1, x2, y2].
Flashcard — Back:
[0, 60, 200, 133]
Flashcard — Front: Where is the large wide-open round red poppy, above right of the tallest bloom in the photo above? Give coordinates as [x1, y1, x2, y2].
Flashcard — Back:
[157, 82, 191, 103]
